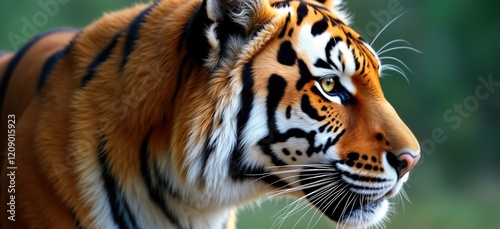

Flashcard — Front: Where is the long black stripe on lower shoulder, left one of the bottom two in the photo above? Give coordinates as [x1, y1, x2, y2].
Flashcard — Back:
[98, 136, 138, 229]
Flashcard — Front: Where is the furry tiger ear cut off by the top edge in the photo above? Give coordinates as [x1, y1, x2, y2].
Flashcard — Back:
[206, 0, 269, 29]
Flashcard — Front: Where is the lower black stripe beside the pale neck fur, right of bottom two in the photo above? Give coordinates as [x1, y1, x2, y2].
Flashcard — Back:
[140, 134, 181, 228]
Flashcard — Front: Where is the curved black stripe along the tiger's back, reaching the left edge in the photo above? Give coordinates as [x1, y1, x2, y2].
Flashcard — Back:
[0, 28, 78, 111]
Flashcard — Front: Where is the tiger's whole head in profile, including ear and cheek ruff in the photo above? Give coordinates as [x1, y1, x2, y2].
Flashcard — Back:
[178, 0, 420, 227]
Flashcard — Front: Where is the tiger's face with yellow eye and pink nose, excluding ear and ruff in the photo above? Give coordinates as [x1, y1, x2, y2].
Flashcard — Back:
[197, 1, 420, 227]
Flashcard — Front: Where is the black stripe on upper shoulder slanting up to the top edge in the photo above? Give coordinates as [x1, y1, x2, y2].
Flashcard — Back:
[120, 1, 158, 71]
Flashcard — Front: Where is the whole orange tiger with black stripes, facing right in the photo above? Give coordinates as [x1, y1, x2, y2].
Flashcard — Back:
[0, 0, 420, 228]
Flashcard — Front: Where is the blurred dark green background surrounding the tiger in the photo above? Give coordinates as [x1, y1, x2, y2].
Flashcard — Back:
[0, 0, 500, 229]
